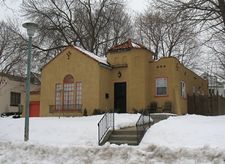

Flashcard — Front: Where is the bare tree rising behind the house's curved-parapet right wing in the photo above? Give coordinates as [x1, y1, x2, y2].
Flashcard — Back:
[136, 11, 199, 67]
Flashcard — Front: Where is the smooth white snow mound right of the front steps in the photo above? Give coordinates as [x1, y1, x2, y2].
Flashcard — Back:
[141, 115, 225, 149]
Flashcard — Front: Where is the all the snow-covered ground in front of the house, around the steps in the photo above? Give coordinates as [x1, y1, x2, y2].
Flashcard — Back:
[0, 114, 225, 164]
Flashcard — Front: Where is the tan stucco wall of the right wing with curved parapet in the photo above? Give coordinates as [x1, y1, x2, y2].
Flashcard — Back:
[150, 57, 208, 114]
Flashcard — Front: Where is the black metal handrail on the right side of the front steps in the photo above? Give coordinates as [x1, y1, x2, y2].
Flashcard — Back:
[136, 111, 151, 144]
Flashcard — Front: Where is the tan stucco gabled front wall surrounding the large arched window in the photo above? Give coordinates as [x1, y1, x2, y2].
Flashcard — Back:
[40, 47, 100, 116]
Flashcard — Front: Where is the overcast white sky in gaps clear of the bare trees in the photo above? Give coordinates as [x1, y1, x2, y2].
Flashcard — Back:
[0, 0, 148, 20]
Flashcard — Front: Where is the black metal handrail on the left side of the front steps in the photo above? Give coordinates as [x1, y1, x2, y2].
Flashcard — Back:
[98, 113, 115, 145]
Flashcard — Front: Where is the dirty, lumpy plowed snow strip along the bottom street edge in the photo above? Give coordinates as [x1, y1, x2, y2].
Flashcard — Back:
[0, 142, 225, 164]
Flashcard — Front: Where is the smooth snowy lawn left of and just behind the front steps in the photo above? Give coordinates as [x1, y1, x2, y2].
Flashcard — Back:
[0, 114, 140, 147]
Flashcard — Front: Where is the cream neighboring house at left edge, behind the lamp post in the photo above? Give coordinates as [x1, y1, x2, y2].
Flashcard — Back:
[0, 73, 40, 114]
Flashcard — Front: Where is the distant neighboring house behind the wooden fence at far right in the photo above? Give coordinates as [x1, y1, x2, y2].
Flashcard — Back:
[202, 73, 225, 97]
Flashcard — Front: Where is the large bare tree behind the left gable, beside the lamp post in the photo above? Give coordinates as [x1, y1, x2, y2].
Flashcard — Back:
[23, 0, 131, 62]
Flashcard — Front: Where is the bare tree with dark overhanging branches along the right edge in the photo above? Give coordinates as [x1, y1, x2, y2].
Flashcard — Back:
[155, 0, 225, 78]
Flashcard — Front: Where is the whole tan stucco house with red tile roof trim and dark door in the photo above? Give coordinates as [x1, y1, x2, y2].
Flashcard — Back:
[34, 40, 208, 116]
